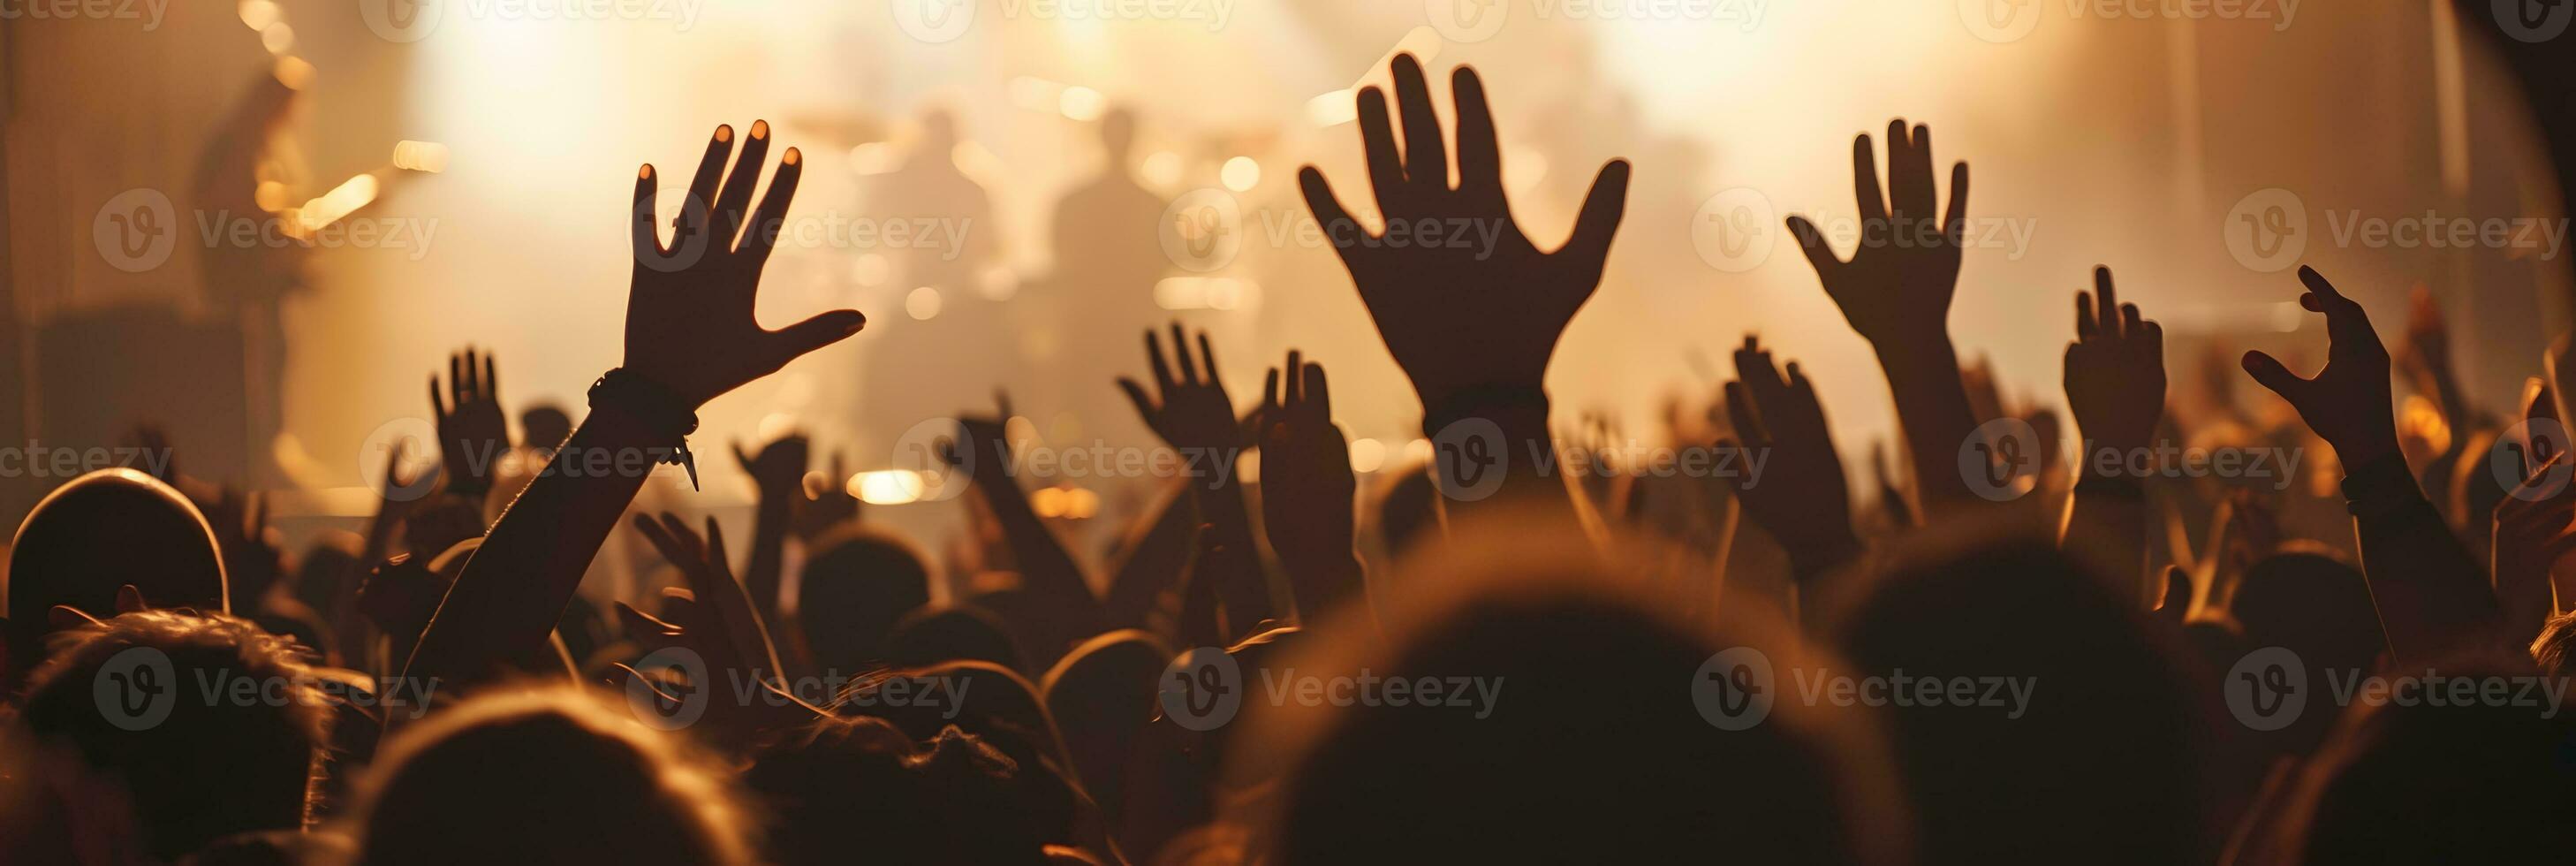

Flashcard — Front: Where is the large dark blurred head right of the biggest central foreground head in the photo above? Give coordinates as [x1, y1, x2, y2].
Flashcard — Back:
[1831, 530, 2216, 866]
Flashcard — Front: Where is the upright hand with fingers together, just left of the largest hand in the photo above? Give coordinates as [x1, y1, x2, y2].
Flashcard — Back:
[1262, 348, 1360, 621]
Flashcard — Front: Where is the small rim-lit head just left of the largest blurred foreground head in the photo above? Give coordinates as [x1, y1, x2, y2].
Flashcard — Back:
[1038, 629, 1172, 809]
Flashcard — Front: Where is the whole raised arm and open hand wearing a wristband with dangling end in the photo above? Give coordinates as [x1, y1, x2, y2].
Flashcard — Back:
[405, 121, 866, 680]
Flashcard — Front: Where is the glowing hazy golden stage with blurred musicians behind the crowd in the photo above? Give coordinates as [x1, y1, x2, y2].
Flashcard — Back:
[0, 0, 2568, 549]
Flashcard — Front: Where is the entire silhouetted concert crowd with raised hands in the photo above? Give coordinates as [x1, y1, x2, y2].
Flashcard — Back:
[0, 54, 2576, 866]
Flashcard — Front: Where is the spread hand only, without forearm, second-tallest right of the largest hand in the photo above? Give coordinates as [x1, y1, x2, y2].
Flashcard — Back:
[1788, 118, 1968, 353]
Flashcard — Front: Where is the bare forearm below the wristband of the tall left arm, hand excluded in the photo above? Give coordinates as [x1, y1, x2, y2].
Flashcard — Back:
[405, 407, 672, 680]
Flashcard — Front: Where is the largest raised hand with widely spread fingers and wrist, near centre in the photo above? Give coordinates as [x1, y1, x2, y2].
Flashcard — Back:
[1299, 54, 1628, 523]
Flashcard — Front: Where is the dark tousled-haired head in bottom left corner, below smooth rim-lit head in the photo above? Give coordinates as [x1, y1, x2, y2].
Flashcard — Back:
[0, 611, 332, 861]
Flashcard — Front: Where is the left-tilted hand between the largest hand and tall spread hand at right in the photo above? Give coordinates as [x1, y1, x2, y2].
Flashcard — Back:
[1718, 335, 1860, 580]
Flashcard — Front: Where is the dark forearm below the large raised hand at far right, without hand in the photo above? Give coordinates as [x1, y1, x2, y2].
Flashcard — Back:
[2345, 451, 2496, 660]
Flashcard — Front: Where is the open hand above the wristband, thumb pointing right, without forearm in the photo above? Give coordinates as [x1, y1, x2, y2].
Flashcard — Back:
[626, 121, 868, 407]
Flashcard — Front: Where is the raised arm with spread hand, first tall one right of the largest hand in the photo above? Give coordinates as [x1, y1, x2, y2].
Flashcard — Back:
[1788, 118, 1976, 515]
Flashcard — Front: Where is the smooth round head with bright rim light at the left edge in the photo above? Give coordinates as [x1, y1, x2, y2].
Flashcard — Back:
[8, 469, 230, 683]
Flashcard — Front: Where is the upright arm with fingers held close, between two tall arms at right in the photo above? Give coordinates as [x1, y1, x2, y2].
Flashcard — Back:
[2058, 268, 2163, 605]
